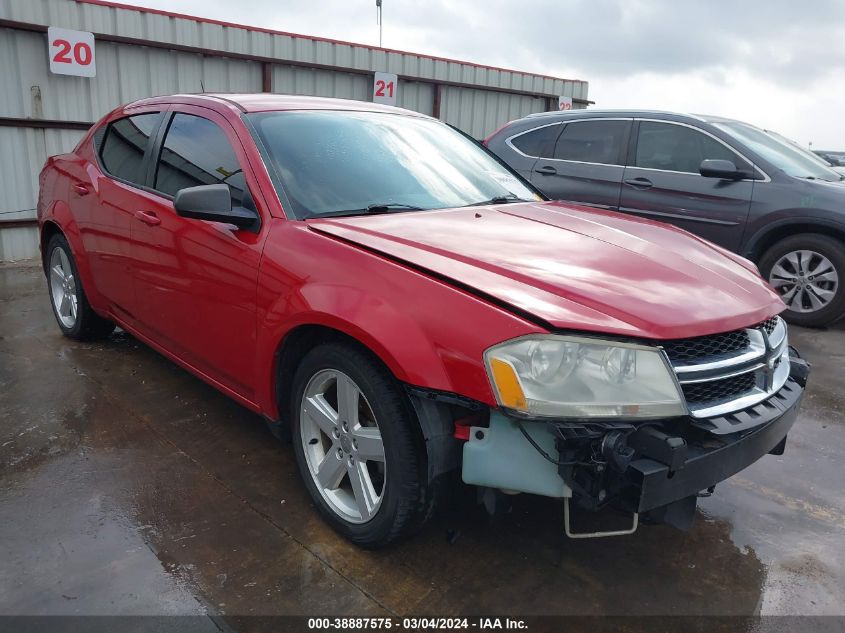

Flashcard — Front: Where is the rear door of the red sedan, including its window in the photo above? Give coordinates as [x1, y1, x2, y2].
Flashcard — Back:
[68, 110, 162, 322]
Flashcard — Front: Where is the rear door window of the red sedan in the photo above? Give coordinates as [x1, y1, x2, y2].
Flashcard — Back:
[100, 112, 160, 185]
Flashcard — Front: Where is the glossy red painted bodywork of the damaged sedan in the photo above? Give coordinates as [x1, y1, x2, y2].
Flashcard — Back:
[38, 95, 783, 418]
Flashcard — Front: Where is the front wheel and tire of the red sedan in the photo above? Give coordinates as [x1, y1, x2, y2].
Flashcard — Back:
[289, 342, 434, 548]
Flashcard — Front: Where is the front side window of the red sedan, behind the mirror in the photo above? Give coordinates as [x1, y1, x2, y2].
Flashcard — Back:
[155, 113, 246, 207]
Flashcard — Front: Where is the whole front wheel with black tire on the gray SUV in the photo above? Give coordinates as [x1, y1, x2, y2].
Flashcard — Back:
[759, 233, 845, 327]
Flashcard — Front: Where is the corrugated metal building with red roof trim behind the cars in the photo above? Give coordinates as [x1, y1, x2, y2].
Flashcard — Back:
[0, 0, 589, 261]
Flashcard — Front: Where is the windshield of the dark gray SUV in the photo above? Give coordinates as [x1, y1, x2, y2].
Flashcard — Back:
[713, 121, 840, 182]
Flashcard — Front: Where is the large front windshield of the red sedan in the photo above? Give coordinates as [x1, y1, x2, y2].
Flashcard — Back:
[247, 111, 541, 219]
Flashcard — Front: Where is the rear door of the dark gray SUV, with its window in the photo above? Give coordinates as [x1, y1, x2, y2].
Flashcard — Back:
[531, 119, 631, 209]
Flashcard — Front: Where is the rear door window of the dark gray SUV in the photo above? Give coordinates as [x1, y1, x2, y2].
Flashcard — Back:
[554, 121, 629, 165]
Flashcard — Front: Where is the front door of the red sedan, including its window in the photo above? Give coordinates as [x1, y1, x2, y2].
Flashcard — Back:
[132, 106, 268, 401]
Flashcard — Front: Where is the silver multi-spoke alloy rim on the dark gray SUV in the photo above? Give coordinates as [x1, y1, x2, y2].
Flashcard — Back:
[769, 250, 839, 313]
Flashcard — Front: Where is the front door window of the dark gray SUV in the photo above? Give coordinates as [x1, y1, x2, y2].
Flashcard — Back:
[634, 121, 750, 174]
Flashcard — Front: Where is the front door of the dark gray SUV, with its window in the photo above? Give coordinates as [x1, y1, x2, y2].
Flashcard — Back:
[619, 120, 754, 250]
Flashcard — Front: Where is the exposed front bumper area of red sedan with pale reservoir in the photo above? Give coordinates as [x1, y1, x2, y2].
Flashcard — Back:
[462, 351, 809, 529]
